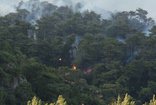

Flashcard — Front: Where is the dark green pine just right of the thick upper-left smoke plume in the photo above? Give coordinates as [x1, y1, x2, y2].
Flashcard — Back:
[36, 12, 63, 42]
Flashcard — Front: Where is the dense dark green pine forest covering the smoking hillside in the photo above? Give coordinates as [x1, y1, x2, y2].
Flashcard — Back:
[0, 0, 156, 105]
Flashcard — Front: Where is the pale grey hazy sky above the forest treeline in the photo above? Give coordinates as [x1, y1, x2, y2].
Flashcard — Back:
[0, 0, 156, 20]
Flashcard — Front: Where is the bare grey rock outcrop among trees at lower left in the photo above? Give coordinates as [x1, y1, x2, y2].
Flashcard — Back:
[11, 75, 27, 90]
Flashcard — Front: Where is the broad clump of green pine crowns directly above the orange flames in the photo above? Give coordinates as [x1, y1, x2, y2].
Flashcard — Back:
[74, 34, 124, 67]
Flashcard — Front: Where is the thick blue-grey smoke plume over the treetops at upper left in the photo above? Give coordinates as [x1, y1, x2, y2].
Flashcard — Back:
[16, 0, 57, 25]
